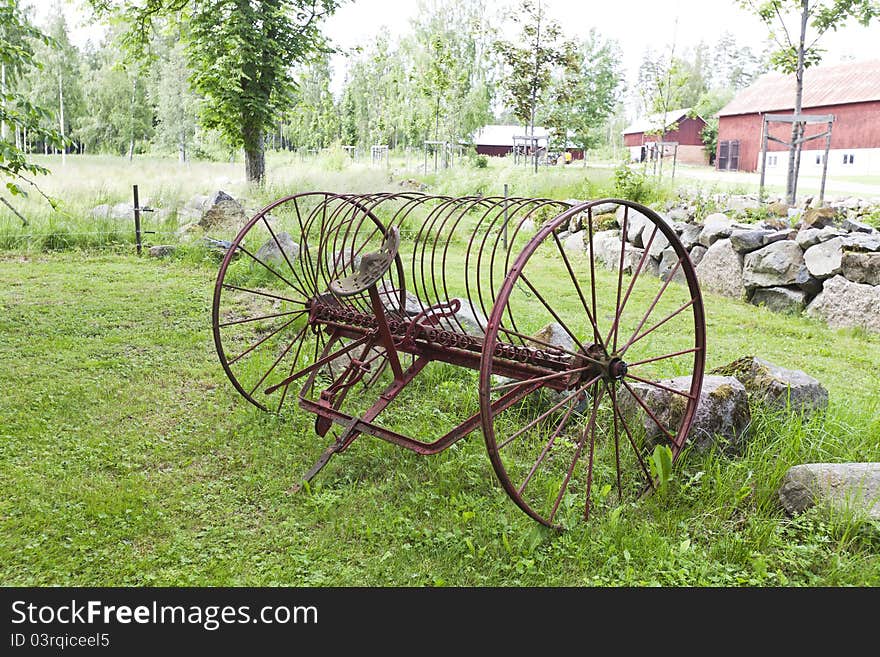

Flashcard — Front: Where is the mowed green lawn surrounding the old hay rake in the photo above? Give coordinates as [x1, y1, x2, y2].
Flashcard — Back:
[0, 253, 880, 586]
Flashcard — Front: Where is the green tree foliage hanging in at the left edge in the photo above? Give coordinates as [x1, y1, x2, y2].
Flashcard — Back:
[0, 0, 64, 224]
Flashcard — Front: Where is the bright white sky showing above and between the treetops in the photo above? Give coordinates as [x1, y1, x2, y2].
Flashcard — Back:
[30, 0, 880, 119]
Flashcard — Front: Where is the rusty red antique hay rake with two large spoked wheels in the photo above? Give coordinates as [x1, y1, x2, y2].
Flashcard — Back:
[213, 192, 705, 527]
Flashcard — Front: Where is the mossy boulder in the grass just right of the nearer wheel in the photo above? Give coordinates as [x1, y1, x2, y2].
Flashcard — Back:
[712, 356, 828, 414]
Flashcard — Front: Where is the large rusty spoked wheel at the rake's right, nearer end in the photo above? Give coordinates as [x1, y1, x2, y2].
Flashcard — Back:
[480, 199, 706, 528]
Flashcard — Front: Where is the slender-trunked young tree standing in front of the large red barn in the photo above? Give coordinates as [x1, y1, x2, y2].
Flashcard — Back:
[740, 0, 880, 205]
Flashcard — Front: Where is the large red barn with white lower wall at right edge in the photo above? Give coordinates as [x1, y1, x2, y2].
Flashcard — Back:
[715, 60, 880, 175]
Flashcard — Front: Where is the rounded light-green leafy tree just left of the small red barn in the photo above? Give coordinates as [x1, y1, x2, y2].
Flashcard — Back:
[544, 29, 623, 164]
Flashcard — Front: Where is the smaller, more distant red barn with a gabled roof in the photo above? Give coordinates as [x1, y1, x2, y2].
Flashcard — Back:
[623, 107, 708, 164]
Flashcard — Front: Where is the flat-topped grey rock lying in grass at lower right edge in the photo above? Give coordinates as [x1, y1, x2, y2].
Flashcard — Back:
[779, 463, 880, 520]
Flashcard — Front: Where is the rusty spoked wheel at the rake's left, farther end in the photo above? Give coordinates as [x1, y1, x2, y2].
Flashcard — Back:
[212, 193, 405, 413]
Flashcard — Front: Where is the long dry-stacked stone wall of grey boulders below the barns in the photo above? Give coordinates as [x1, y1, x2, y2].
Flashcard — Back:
[562, 193, 880, 332]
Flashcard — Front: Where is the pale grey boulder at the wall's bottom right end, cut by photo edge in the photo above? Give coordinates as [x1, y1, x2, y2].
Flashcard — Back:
[806, 272, 880, 332]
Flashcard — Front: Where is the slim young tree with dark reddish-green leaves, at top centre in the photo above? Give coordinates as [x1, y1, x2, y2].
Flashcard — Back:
[495, 0, 577, 149]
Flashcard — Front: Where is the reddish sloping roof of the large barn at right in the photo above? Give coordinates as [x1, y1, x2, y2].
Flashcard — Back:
[718, 59, 880, 116]
